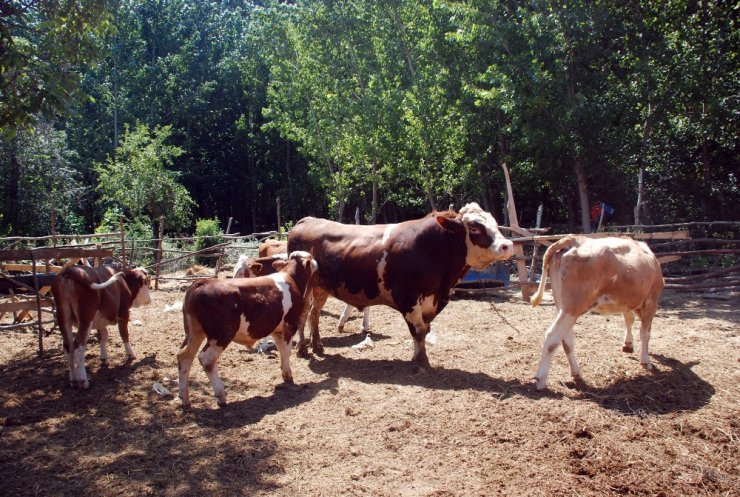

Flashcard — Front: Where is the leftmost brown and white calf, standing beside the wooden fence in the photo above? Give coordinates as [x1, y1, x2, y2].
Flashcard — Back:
[51, 266, 151, 388]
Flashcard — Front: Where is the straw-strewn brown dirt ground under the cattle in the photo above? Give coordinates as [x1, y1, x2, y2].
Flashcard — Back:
[0, 276, 740, 497]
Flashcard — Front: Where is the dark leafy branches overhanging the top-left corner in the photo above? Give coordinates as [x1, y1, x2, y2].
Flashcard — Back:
[0, 0, 108, 135]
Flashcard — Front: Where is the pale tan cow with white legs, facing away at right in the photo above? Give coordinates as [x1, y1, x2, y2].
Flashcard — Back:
[532, 235, 663, 390]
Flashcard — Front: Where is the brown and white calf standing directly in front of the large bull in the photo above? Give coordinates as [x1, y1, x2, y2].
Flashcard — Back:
[177, 252, 317, 406]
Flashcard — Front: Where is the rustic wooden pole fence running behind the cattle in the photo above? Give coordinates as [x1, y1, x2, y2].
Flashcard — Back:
[0, 218, 740, 355]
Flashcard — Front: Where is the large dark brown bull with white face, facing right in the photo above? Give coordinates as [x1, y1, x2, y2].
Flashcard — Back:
[288, 203, 514, 369]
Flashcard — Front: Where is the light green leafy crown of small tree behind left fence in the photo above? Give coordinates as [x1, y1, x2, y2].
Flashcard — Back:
[95, 124, 194, 232]
